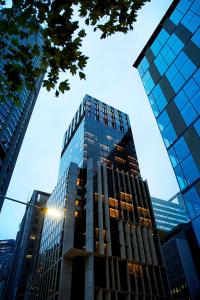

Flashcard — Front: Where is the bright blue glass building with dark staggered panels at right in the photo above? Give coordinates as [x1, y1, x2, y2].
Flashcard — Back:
[134, 0, 200, 223]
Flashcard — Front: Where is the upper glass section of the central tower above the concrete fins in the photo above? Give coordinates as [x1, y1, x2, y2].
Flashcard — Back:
[59, 95, 139, 177]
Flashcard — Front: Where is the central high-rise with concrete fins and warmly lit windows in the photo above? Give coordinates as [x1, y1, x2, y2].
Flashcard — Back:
[27, 95, 168, 300]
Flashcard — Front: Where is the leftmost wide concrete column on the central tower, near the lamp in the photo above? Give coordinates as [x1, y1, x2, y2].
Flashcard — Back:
[63, 163, 78, 255]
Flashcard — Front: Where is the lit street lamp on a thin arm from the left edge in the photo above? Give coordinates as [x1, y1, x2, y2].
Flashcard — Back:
[0, 194, 63, 219]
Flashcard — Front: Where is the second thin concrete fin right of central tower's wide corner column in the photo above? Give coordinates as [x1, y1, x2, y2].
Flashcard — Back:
[103, 165, 112, 256]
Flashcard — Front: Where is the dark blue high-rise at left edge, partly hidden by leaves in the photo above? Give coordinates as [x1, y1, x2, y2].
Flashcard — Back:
[0, 12, 43, 211]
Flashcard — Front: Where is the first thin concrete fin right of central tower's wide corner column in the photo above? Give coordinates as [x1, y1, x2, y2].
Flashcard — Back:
[97, 161, 104, 254]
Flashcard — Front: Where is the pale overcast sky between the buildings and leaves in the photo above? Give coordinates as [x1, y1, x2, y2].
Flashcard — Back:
[0, 0, 178, 239]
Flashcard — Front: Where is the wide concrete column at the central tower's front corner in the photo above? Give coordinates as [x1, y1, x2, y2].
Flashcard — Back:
[86, 158, 94, 252]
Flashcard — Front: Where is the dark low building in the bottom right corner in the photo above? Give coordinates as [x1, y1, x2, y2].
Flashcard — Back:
[162, 222, 200, 300]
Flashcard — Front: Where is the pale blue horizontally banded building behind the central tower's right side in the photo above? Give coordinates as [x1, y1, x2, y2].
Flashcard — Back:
[151, 193, 189, 237]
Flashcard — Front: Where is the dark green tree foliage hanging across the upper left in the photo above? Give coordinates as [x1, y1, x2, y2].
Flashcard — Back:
[0, 0, 150, 102]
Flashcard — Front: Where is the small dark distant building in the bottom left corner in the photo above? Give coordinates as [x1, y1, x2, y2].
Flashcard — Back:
[0, 240, 16, 299]
